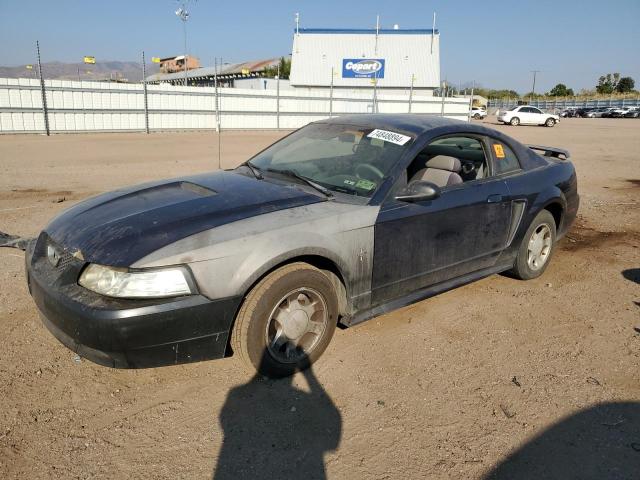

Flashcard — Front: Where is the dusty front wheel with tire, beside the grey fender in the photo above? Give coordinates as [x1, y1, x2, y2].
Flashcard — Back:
[231, 262, 338, 378]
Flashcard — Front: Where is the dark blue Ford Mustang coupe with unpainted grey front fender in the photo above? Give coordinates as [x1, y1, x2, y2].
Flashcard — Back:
[26, 115, 579, 377]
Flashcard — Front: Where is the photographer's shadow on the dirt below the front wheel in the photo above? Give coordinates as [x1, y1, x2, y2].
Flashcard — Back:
[213, 351, 342, 480]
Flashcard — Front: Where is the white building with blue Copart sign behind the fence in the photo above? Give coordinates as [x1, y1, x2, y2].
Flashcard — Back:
[290, 28, 440, 95]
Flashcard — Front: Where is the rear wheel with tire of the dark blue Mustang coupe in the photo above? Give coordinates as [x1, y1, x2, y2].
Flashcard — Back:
[509, 210, 556, 280]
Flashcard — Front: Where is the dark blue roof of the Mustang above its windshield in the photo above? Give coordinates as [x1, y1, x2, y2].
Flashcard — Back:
[314, 113, 467, 135]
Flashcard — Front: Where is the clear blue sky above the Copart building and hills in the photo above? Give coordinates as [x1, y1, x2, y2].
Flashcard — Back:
[0, 0, 640, 93]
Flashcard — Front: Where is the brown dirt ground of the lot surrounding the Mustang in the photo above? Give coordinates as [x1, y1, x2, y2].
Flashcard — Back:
[0, 117, 640, 479]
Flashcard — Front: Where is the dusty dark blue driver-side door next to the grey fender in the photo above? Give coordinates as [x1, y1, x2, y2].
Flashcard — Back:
[372, 135, 511, 305]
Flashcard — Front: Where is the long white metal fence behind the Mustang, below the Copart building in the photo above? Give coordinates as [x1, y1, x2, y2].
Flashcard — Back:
[0, 78, 469, 133]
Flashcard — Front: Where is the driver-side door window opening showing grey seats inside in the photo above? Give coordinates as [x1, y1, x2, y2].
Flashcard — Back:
[407, 135, 489, 188]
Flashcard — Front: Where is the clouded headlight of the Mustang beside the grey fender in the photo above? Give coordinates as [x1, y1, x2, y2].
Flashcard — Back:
[78, 263, 195, 298]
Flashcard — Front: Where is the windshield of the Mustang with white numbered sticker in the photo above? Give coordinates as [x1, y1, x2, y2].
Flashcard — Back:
[249, 123, 413, 197]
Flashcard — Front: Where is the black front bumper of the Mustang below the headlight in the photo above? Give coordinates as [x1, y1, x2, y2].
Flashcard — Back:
[26, 235, 242, 368]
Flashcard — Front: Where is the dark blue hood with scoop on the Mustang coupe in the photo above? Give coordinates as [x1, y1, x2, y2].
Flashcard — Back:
[45, 171, 326, 267]
